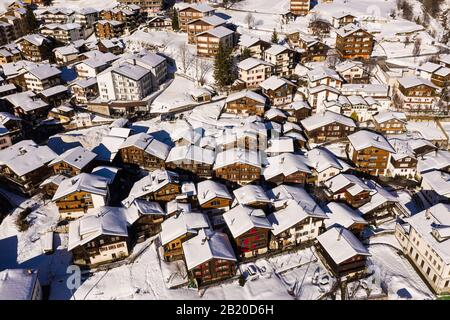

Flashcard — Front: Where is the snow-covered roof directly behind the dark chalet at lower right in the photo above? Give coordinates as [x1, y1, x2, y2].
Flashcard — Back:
[325, 202, 368, 228]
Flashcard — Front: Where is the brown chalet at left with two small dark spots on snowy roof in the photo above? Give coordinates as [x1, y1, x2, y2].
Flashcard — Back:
[49, 146, 97, 178]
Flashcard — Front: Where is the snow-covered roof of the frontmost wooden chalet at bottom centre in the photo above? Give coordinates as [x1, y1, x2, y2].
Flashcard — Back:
[183, 229, 237, 270]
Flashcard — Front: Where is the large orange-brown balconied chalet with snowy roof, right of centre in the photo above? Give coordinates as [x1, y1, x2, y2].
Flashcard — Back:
[347, 130, 395, 176]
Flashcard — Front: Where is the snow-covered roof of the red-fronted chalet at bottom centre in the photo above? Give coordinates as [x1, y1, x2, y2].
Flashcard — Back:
[223, 205, 272, 238]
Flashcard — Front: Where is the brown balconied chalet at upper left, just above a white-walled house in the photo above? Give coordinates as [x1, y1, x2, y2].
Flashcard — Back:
[16, 34, 53, 62]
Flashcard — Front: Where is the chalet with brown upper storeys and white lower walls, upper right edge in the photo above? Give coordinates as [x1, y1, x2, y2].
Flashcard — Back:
[397, 77, 439, 112]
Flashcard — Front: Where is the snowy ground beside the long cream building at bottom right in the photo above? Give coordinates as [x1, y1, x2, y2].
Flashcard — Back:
[369, 245, 433, 300]
